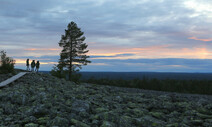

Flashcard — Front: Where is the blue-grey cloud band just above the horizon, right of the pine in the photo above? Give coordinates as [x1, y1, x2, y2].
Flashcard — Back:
[82, 58, 212, 72]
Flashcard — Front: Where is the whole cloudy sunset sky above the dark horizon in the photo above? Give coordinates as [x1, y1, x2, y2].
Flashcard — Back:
[0, 0, 212, 72]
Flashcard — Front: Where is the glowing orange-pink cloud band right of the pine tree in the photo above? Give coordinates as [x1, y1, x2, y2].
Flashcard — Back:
[89, 45, 212, 59]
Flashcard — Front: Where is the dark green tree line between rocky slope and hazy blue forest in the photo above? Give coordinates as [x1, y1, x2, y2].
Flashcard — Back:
[82, 77, 212, 95]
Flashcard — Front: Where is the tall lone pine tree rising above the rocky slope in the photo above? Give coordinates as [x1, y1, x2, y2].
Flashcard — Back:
[56, 21, 91, 80]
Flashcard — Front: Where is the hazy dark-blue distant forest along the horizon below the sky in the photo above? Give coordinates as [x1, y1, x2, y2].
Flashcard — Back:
[80, 72, 212, 80]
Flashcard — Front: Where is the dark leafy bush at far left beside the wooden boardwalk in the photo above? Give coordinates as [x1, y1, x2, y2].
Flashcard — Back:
[0, 51, 15, 74]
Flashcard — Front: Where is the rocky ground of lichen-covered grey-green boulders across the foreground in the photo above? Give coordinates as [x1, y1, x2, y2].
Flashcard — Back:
[0, 73, 212, 127]
